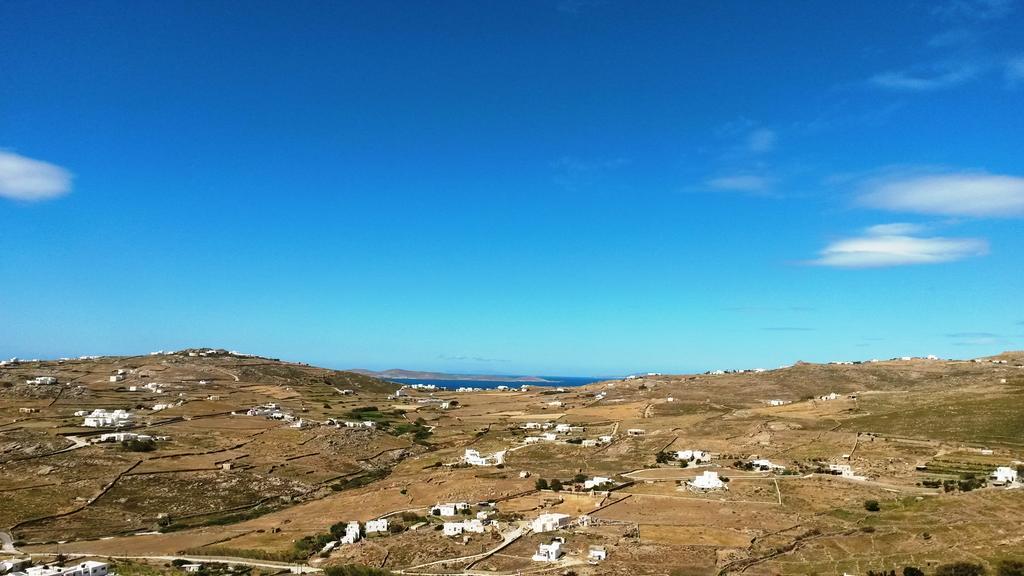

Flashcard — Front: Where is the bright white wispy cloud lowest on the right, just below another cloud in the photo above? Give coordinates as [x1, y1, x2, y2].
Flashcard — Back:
[809, 227, 988, 269]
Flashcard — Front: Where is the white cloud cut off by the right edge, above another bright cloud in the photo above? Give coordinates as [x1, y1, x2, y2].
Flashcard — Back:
[858, 172, 1024, 217]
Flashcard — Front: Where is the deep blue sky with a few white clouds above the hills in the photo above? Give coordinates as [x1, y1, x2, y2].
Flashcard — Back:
[0, 0, 1024, 375]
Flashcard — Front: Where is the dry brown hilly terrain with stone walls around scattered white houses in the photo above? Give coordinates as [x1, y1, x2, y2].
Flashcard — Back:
[0, 348, 1024, 575]
